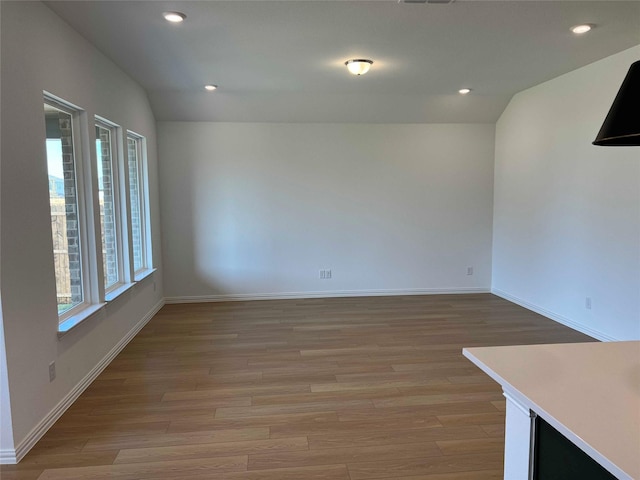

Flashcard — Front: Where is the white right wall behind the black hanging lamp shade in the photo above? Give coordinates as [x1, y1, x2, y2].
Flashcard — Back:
[493, 47, 640, 340]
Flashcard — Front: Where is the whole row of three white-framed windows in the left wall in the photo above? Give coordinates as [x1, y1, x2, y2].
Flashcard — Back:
[44, 96, 153, 332]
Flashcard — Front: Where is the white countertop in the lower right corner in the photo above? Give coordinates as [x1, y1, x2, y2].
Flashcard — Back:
[463, 341, 640, 480]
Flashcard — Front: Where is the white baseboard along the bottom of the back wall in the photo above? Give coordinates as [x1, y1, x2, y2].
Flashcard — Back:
[165, 287, 491, 304]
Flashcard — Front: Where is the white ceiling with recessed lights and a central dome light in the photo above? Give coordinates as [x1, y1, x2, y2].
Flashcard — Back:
[46, 0, 640, 123]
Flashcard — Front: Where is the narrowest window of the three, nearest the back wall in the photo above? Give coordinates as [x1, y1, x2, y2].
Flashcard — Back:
[127, 132, 151, 276]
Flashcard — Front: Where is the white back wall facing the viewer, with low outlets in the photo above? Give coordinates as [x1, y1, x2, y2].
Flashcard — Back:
[158, 122, 494, 301]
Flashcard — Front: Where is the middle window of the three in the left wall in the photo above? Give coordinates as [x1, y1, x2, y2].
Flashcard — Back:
[95, 120, 123, 293]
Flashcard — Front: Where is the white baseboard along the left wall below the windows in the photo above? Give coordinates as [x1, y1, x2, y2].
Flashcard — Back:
[0, 299, 164, 464]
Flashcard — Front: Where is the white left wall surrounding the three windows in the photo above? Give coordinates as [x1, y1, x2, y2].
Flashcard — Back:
[0, 1, 162, 454]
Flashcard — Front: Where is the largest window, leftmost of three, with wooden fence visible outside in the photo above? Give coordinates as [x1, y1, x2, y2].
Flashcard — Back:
[44, 99, 90, 320]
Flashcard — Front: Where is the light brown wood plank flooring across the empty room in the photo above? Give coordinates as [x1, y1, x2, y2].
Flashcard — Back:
[0, 294, 593, 480]
